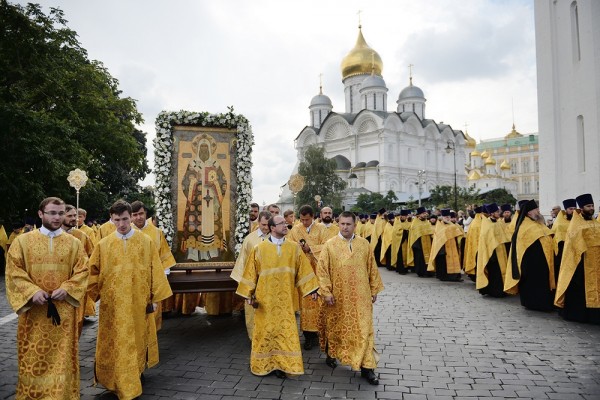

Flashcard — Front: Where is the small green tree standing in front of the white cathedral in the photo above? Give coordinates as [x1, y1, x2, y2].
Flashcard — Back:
[296, 145, 346, 208]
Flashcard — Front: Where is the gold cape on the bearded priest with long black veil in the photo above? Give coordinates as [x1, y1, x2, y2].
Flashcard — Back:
[504, 216, 556, 294]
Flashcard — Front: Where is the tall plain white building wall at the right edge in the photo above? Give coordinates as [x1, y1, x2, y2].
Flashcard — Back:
[535, 0, 600, 211]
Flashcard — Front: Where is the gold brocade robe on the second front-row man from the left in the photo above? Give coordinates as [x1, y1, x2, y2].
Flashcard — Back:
[89, 231, 172, 399]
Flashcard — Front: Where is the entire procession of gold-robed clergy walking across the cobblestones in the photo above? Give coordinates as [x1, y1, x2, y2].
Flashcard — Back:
[6, 194, 600, 399]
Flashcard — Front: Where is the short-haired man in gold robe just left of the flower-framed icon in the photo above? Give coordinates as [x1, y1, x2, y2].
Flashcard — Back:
[131, 200, 176, 331]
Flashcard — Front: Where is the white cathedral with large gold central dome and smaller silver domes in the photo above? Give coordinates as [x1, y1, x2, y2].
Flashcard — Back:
[278, 26, 476, 210]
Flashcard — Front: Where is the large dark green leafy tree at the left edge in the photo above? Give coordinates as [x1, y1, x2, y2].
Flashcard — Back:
[0, 0, 149, 220]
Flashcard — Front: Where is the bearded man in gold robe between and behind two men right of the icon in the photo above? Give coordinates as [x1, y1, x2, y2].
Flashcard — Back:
[288, 205, 325, 350]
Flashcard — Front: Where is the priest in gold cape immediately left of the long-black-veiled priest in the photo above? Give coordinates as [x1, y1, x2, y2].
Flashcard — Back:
[475, 203, 510, 297]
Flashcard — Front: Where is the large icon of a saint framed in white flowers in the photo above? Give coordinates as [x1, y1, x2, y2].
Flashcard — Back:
[155, 109, 254, 268]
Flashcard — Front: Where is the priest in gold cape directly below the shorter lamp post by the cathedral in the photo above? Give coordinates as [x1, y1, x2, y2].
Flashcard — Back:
[406, 207, 433, 278]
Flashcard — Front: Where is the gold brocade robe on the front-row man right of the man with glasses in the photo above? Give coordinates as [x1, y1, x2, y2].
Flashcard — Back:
[317, 236, 383, 371]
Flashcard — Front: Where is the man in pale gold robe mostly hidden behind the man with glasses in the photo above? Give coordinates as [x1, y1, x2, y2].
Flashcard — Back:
[231, 211, 270, 340]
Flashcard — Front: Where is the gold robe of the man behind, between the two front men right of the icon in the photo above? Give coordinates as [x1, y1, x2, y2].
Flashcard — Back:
[286, 221, 326, 332]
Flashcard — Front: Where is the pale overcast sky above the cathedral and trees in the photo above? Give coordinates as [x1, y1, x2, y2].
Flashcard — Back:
[20, 0, 538, 204]
